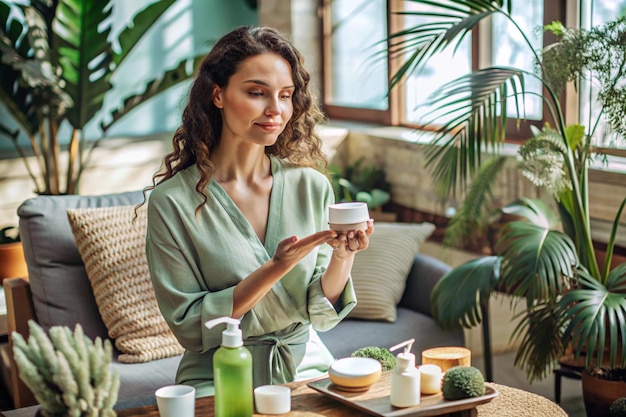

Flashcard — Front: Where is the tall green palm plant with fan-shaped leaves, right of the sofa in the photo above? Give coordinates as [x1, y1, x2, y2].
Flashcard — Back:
[388, 0, 626, 415]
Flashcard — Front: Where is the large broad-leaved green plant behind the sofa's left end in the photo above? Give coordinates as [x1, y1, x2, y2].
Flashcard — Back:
[0, 0, 200, 194]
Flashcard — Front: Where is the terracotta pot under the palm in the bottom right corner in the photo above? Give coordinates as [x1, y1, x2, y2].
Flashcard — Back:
[582, 370, 626, 417]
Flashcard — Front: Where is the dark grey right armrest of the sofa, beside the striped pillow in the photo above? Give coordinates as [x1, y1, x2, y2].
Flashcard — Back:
[400, 254, 452, 317]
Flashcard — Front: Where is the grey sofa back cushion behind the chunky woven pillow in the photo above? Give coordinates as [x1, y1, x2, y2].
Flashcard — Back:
[18, 191, 143, 339]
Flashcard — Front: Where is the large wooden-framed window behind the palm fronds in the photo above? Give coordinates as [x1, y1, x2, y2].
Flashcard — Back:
[324, 0, 626, 148]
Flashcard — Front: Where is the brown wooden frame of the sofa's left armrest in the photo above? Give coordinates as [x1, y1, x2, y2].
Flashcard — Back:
[2, 278, 37, 408]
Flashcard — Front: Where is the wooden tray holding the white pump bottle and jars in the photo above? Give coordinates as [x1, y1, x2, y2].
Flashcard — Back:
[307, 372, 498, 417]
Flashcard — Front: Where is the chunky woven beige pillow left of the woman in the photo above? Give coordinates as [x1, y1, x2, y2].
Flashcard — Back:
[67, 206, 184, 363]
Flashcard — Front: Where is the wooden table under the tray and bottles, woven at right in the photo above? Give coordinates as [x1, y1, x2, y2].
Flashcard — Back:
[1, 382, 567, 417]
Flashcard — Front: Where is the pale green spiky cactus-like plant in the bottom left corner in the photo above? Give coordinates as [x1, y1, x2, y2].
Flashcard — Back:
[11, 320, 119, 417]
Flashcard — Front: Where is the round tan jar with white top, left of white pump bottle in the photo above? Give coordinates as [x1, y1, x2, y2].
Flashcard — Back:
[328, 357, 382, 391]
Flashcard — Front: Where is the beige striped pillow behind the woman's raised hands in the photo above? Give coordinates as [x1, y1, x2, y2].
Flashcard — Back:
[348, 222, 435, 323]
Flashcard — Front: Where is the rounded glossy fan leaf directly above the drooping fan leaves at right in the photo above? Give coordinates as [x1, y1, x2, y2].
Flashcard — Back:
[496, 221, 578, 306]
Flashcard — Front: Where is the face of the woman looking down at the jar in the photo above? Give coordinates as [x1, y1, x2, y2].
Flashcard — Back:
[213, 52, 295, 146]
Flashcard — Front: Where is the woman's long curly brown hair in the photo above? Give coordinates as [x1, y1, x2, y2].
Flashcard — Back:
[144, 26, 327, 212]
